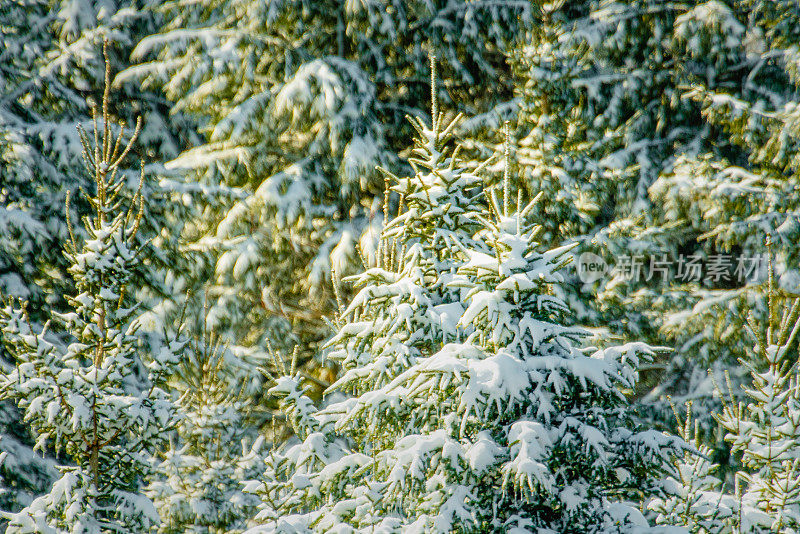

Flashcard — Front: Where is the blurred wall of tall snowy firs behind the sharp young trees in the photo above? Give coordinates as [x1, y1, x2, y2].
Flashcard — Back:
[0, 0, 800, 532]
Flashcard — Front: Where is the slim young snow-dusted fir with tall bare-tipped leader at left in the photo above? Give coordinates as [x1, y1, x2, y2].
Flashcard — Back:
[0, 70, 182, 534]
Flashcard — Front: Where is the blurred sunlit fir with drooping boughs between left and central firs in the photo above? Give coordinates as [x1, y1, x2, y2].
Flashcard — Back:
[125, 0, 534, 372]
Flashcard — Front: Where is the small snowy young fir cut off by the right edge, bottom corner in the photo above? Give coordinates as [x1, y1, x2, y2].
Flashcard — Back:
[718, 269, 800, 534]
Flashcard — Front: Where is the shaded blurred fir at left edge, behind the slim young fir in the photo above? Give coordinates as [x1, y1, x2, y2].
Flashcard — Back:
[0, 0, 197, 510]
